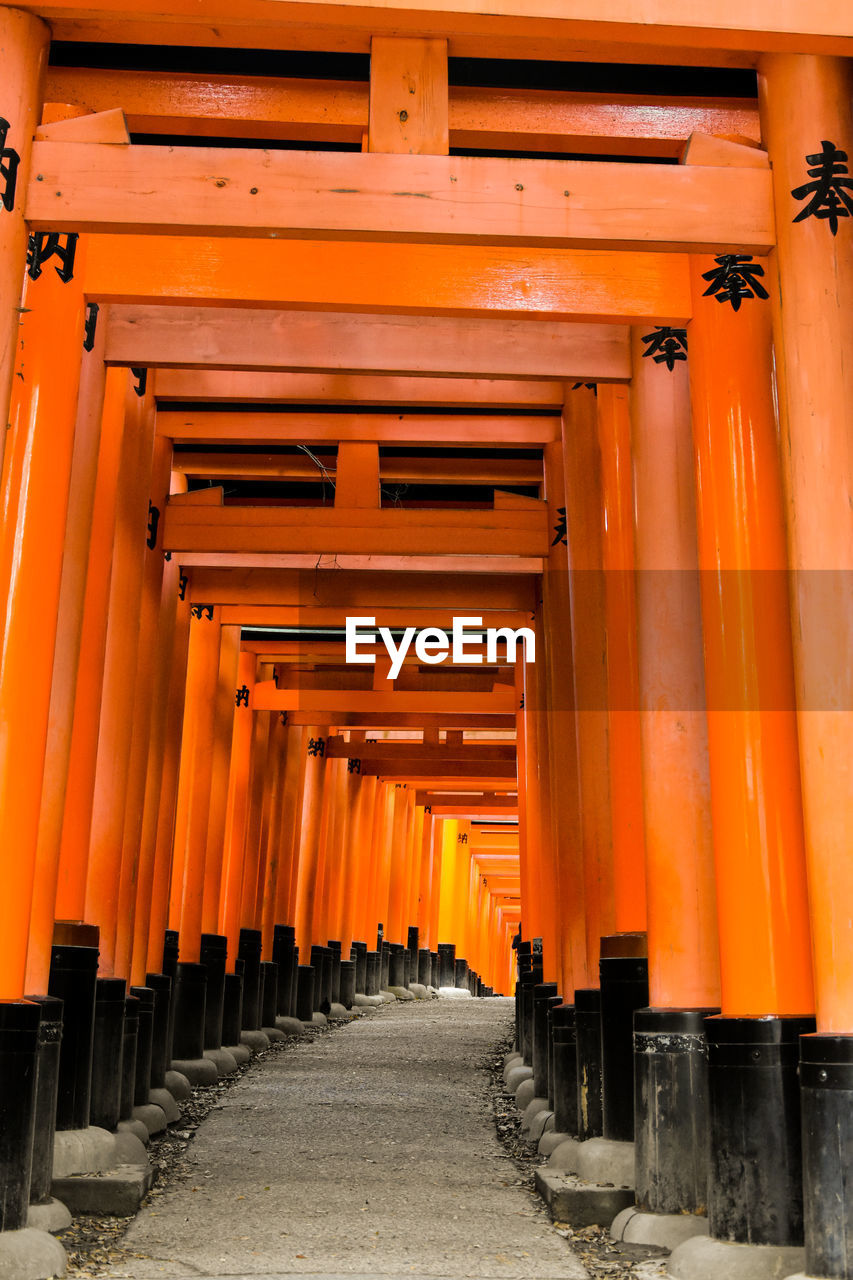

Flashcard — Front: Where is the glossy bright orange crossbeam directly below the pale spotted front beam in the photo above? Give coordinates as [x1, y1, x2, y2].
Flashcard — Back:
[86, 236, 693, 325]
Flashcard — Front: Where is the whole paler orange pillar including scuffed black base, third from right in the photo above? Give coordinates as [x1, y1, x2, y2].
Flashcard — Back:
[631, 329, 720, 1233]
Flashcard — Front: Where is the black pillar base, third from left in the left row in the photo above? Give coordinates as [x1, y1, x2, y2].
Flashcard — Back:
[47, 946, 97, 1130]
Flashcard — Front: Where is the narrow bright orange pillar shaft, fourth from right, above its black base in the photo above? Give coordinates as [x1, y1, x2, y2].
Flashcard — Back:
[598, 387, 646, 933]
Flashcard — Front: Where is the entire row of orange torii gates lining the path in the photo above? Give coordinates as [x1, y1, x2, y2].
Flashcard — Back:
[0, 0, 853, 1277]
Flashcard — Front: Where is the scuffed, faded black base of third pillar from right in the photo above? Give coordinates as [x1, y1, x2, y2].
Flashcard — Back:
[634, 1009, 717, 1213]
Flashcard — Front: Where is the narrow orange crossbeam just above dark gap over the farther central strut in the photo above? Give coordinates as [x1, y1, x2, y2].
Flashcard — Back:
[156, 414, 565, 450]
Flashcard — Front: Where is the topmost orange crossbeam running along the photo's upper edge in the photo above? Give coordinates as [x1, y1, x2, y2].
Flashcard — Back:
[18, 0, 853, 65]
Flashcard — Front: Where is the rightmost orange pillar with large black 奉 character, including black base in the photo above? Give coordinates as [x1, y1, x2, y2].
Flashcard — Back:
[760, 55, 853, 1277]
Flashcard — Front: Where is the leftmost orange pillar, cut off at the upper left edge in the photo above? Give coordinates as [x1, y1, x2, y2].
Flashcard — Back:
[0, 8, 50, 435]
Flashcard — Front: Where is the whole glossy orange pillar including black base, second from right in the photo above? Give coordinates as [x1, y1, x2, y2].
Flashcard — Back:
[688, 256, 813, 1245]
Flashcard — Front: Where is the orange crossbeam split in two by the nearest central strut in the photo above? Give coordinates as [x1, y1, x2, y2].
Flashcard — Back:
[45, 67, 760, 156]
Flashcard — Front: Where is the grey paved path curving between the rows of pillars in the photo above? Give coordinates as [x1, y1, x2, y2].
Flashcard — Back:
[104, 1000, 587, 1280]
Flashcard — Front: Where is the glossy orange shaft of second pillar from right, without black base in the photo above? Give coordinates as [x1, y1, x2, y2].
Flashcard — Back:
[689, 259, 815, 1016]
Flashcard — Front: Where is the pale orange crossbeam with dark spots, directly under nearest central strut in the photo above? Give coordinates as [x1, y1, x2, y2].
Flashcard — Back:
[24, 142, 775, 253]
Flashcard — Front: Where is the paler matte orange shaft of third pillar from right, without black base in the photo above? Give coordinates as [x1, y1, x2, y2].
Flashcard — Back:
[631, 329, 720, 1009]
